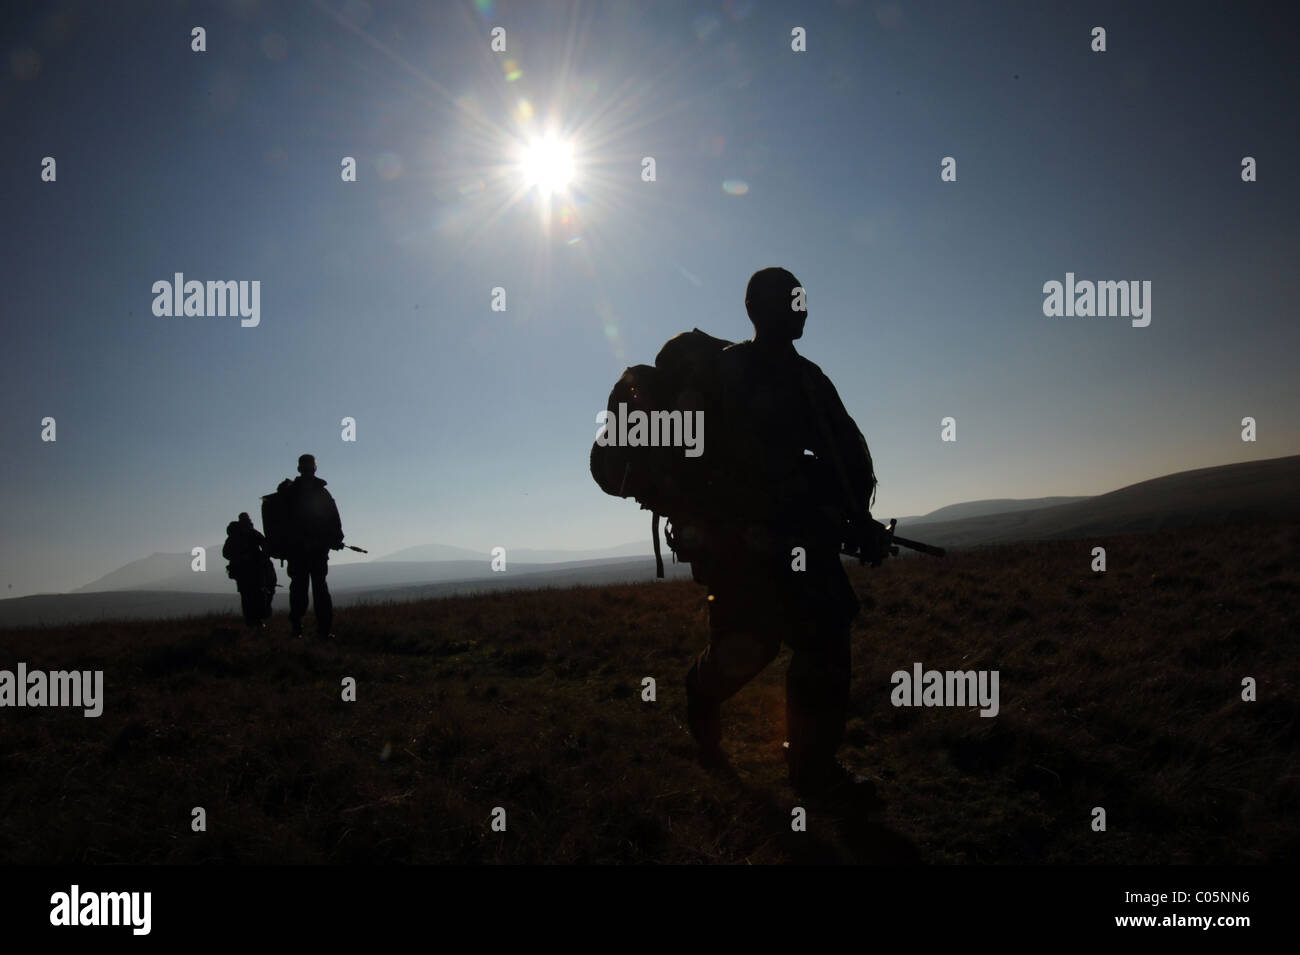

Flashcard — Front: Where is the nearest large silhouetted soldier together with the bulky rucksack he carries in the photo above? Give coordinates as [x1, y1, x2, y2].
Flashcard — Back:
[592, 263, 889, 806]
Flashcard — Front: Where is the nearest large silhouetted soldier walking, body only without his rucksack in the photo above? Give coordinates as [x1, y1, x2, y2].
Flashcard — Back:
[686, 269, 884, 803]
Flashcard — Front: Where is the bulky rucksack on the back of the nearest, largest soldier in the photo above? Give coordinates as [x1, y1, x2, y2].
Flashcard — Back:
[590, 329, 732, 577]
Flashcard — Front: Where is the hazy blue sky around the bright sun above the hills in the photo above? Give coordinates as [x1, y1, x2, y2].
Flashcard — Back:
[0, 0, 1300, 596]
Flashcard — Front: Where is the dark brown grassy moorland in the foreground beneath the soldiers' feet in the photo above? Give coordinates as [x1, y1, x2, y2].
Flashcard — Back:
[0, 524, 1300, 863]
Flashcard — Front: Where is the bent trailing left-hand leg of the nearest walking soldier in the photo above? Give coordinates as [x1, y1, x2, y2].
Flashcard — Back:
[686, 586, 781, 750]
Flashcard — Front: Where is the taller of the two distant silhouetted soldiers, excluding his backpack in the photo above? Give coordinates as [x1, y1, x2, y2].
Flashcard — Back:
[285, 455, 343, 637]
